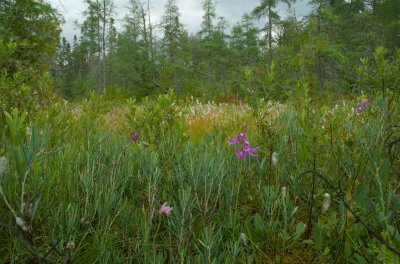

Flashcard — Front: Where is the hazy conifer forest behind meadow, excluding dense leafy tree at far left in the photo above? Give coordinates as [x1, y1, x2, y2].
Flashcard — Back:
[46, 0, 400, 100]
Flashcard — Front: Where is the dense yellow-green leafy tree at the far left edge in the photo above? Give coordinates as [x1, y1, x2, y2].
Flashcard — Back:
[0, 0, 60, 113]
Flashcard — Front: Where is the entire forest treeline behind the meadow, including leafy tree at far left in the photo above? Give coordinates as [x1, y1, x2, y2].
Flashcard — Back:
[0, 0, 400, 108]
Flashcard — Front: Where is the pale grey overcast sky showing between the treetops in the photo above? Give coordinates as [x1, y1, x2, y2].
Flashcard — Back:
[48, 0, 312, 41]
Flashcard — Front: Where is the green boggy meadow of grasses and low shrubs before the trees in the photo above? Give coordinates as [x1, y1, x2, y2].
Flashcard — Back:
[0, 90, 400, 263]
